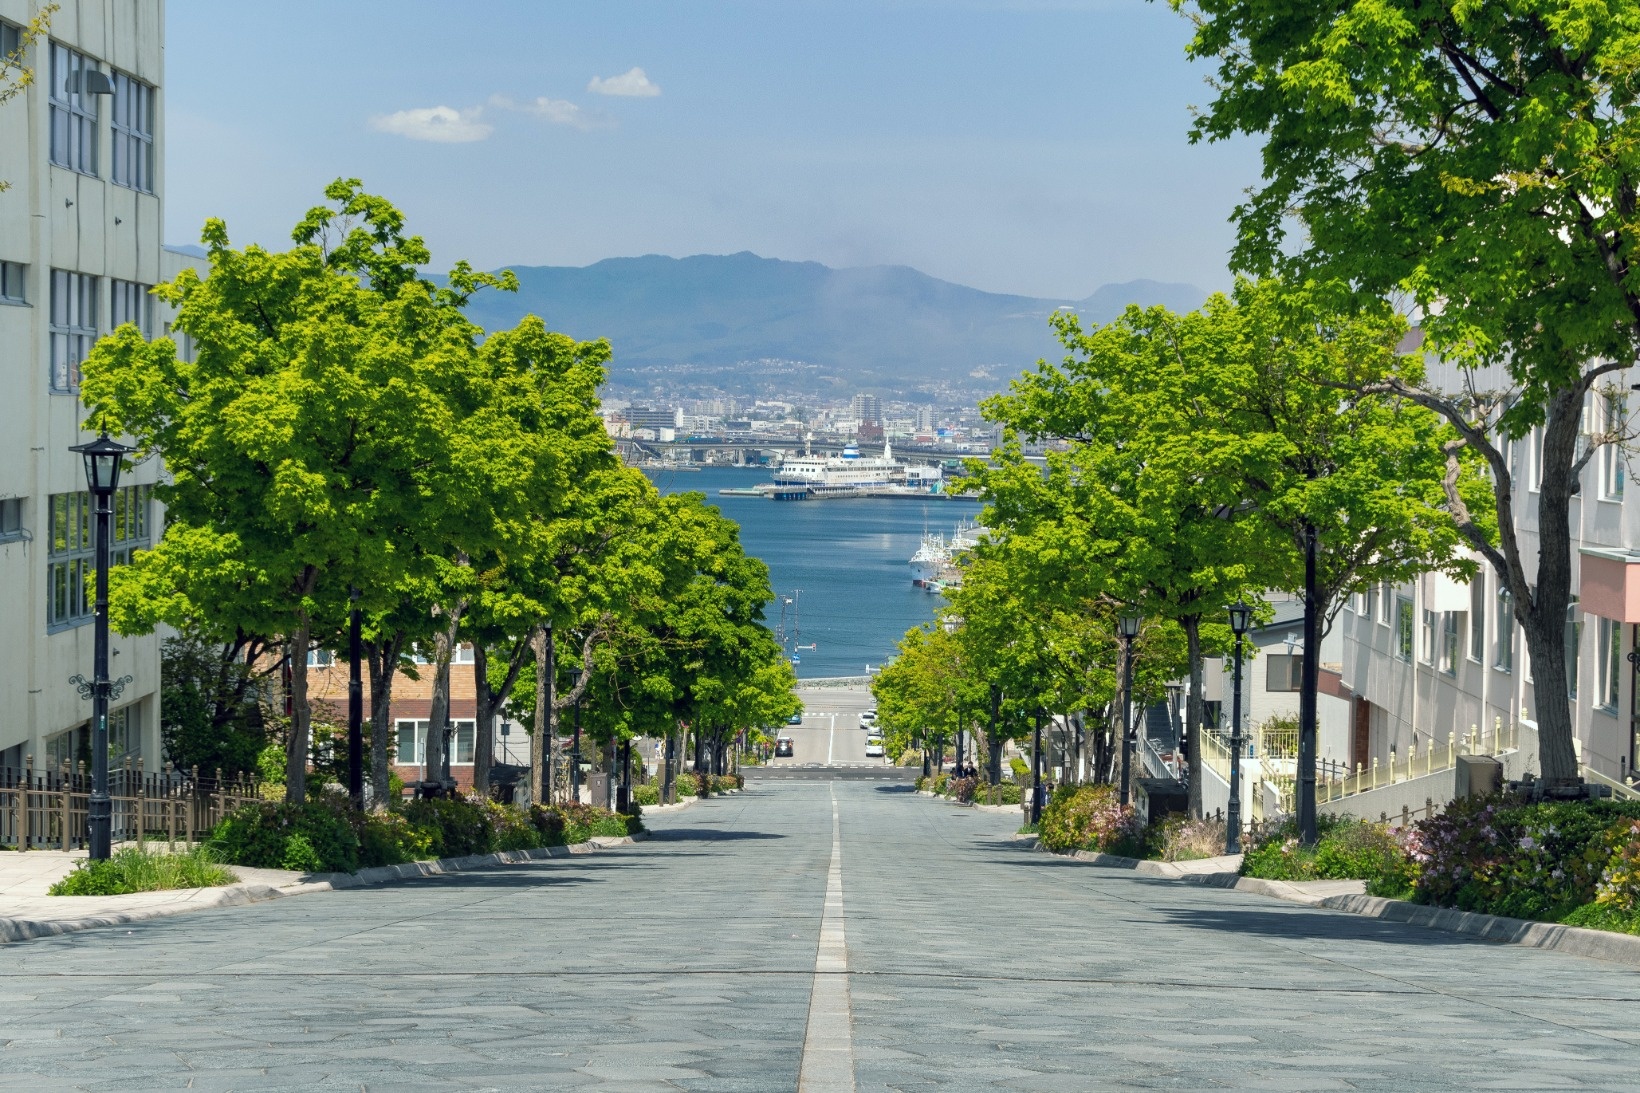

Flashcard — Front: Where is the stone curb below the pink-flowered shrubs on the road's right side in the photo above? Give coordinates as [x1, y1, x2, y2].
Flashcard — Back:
[1032, 842, 1640, 967]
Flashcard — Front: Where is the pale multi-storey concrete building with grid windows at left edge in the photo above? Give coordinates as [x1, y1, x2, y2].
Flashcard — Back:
[0, 0, 169, 770]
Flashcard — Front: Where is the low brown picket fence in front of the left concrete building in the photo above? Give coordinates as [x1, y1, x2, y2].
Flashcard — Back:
[0, 757, 262, 850]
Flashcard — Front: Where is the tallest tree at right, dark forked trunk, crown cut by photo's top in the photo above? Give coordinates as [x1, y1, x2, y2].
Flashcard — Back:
[1169, 0, 1640, 783]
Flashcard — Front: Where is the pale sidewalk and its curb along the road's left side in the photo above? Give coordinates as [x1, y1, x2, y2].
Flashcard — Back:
[0, 799, 694, 942]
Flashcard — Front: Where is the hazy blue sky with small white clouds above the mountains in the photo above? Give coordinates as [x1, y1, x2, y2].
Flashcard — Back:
[166, 0, 1258, 299]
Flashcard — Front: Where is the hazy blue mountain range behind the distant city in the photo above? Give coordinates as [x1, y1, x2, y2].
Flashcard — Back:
[455, 253, 1207, 386]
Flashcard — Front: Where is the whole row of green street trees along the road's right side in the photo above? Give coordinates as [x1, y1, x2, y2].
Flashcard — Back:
[892, 0, 1640, 830]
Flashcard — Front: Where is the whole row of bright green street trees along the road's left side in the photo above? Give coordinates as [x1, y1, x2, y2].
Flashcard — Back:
[82, 181, 795, 801]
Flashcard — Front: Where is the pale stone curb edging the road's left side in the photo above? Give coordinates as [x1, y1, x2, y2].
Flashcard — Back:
[0, 827, 652, 942]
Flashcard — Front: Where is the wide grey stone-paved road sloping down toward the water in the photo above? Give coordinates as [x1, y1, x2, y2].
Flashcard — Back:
[0, 781, 1640, 1093]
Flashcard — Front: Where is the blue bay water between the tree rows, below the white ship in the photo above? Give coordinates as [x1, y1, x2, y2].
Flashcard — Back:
[648, 468, 979, 679]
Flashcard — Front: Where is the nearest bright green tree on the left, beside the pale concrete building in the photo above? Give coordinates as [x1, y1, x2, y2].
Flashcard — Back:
[82, 181, 512, 798]
